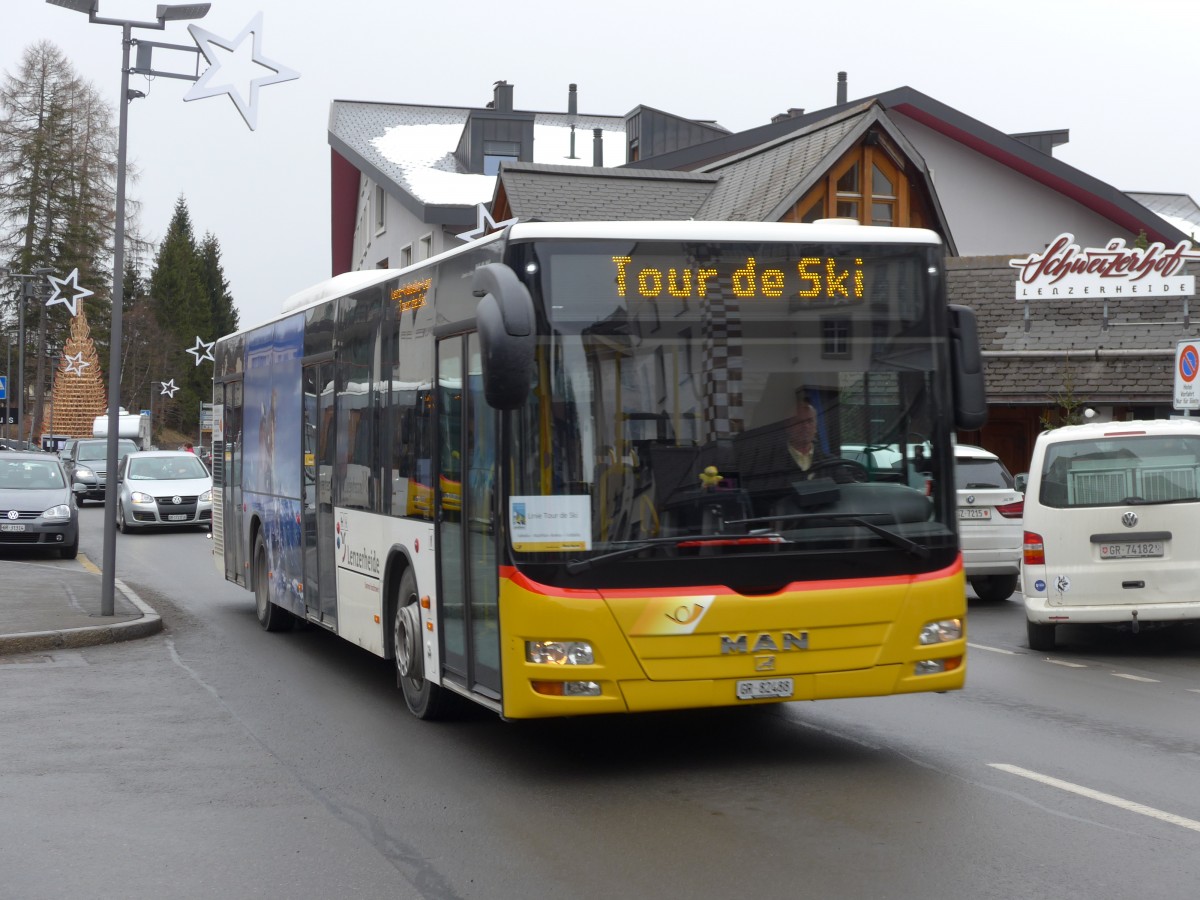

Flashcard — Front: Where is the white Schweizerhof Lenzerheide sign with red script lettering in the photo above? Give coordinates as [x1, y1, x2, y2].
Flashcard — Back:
[1008, 233, 1200, 301]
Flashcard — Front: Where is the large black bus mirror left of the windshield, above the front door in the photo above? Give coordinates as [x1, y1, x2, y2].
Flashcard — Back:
[473, 263, 536, 409]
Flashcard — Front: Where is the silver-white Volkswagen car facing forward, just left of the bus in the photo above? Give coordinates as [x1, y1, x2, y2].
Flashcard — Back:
[116, 450, 212, 532]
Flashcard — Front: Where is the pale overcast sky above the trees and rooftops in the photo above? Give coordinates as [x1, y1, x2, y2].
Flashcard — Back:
[0, 0, 1200, 331]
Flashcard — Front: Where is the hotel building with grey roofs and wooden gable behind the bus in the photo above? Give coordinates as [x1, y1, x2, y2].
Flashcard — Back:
[330, 73, 1200, 480]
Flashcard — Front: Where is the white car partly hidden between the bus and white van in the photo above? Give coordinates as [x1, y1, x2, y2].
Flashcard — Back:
[954, 444, 1025, 602]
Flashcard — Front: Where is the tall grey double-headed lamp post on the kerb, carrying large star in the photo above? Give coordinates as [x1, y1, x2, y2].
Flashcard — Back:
[46, 0, 211, 616]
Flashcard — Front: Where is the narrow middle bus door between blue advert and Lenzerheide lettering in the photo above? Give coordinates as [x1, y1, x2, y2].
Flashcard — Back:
[300, 360, 337, 626]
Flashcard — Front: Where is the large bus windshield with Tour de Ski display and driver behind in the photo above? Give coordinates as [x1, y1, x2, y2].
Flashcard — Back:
[509, 241, 953, 562]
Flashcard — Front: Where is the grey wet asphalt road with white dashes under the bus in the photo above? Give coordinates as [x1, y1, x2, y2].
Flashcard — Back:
[0, 508, 1200, 900]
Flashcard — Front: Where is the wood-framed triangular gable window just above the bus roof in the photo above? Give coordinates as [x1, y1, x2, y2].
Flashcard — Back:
[782, 133, 907, 226]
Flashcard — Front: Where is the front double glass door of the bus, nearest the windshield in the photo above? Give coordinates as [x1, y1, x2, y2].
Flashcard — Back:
[437, 334, 500, 700]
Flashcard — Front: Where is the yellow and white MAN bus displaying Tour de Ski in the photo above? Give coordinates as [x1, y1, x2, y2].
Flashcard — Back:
[212, 221, 986, 719]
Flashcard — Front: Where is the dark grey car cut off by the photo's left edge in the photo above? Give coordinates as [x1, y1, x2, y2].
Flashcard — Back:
[0, 450, 79, 559]
